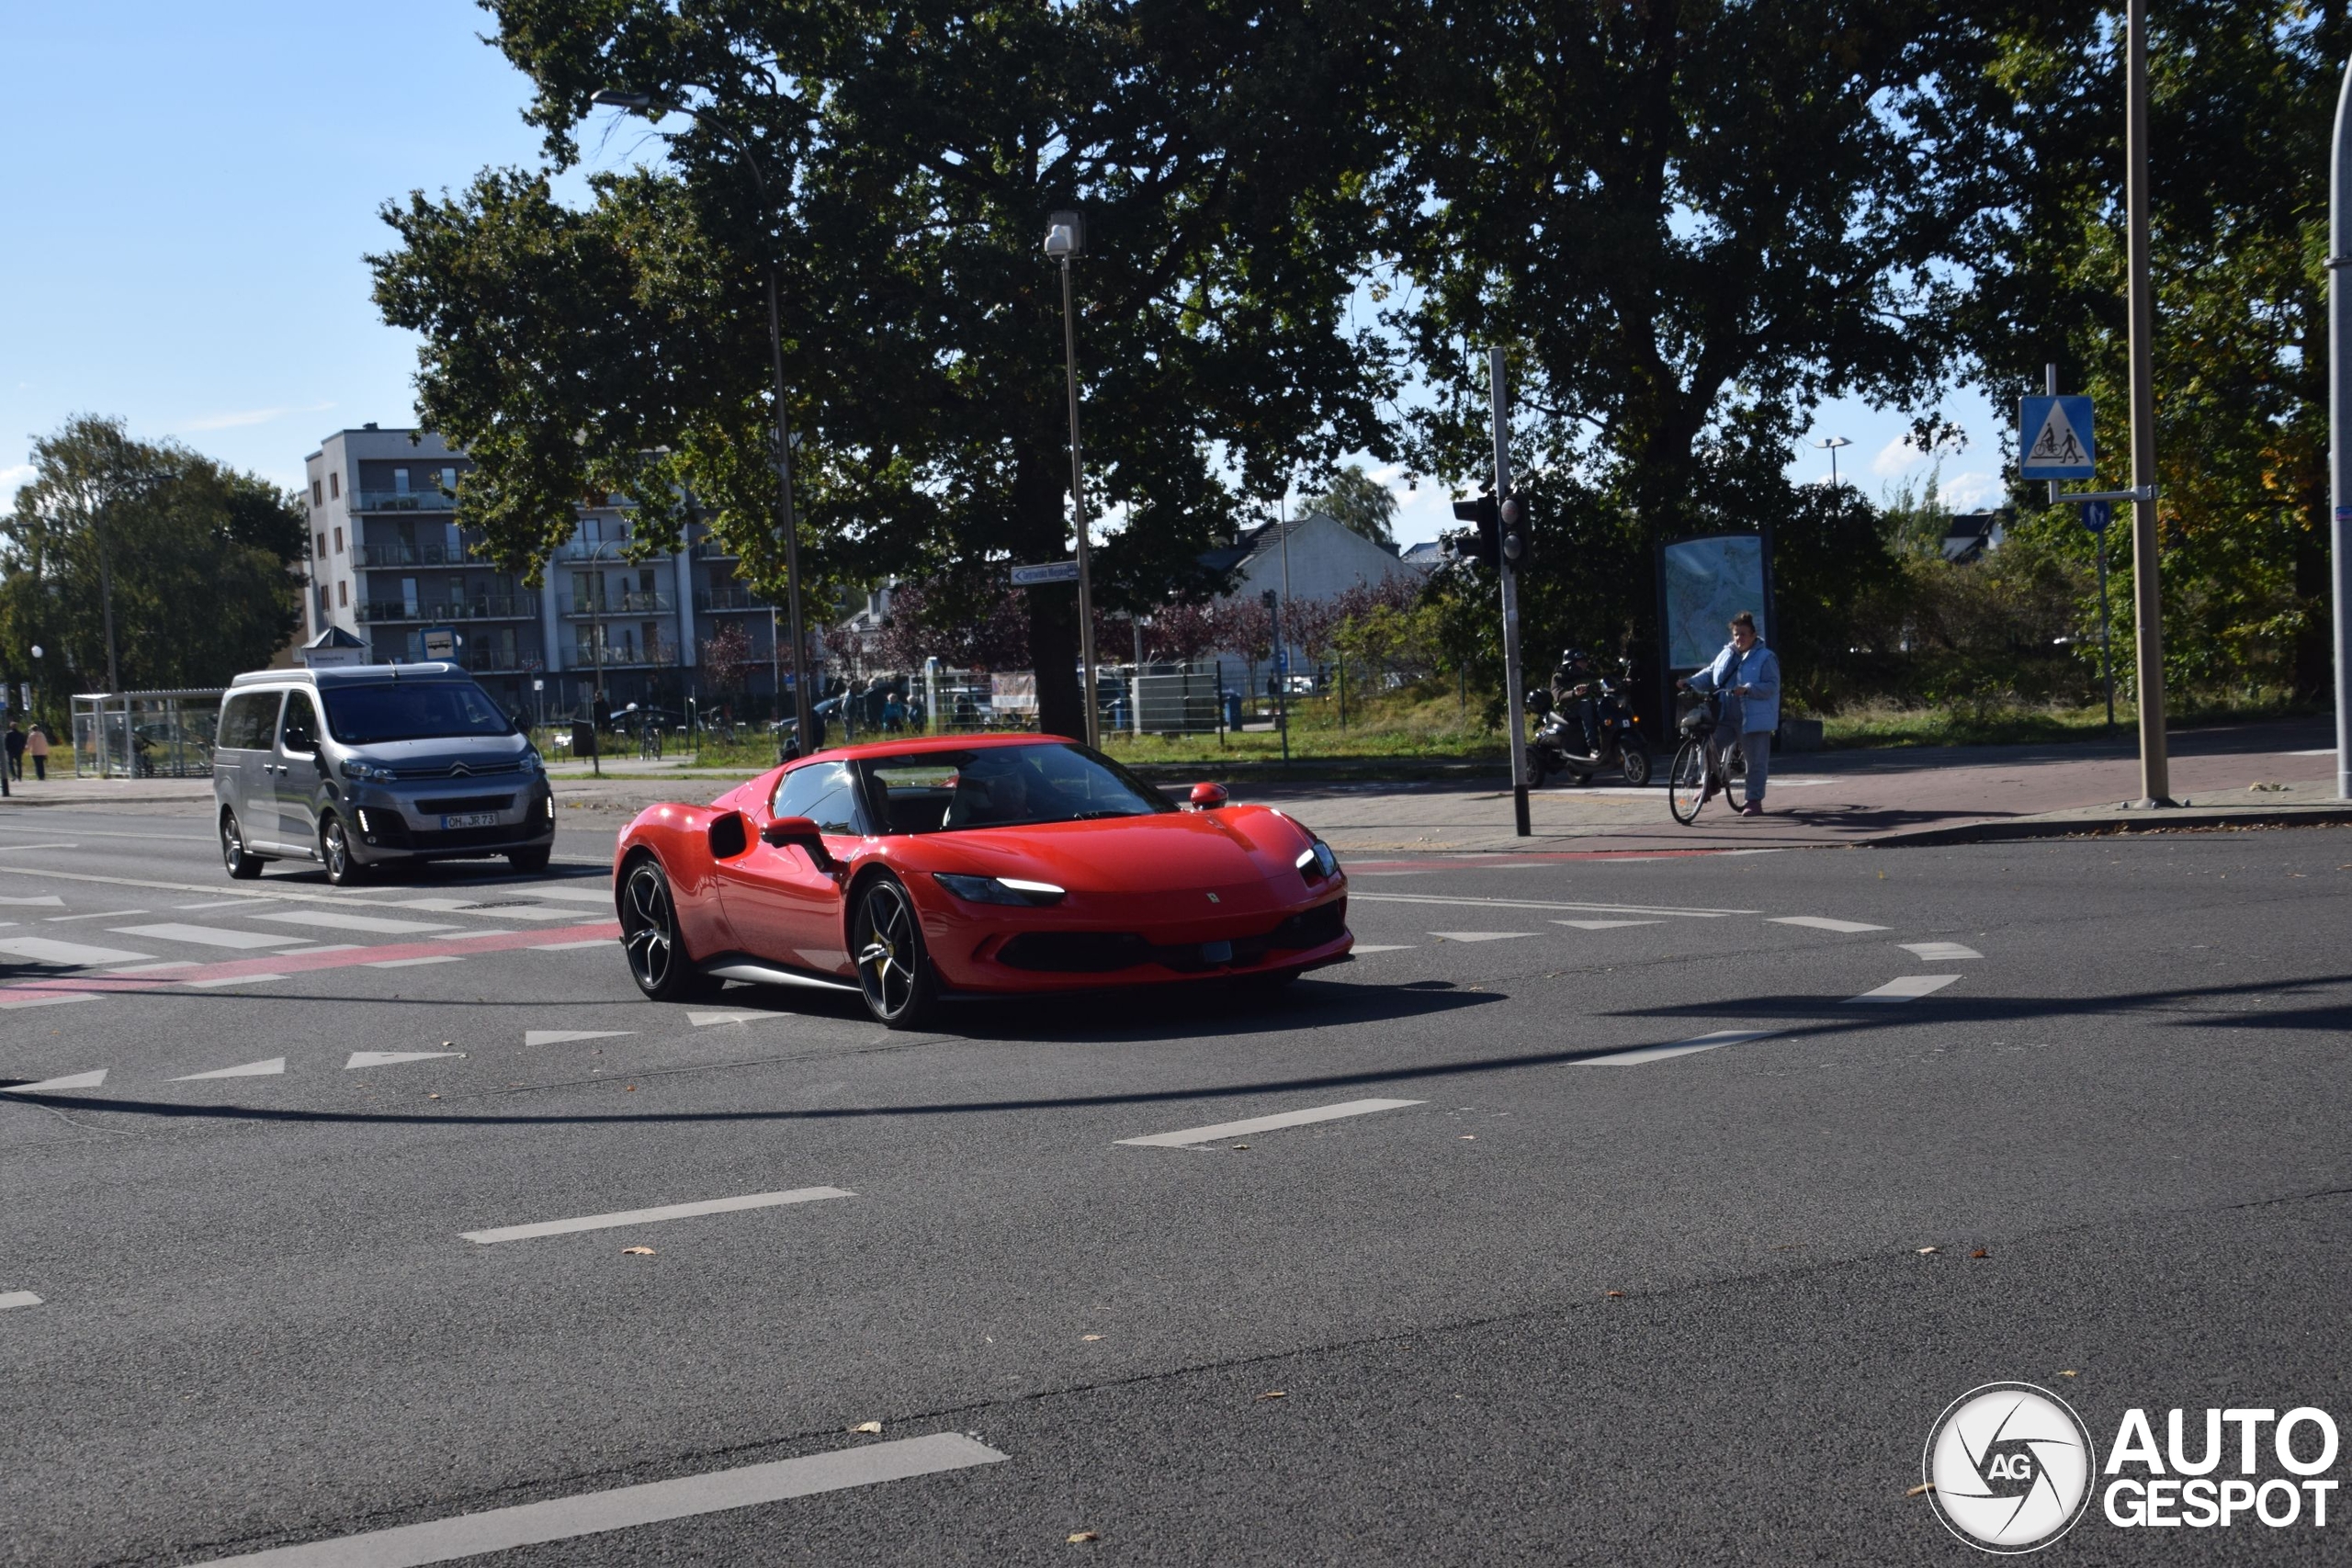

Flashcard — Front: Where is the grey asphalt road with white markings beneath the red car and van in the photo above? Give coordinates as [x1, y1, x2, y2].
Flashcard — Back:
[0, 808, 2352, 1568]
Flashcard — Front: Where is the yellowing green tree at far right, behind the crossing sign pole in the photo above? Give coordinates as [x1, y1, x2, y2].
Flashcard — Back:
[1964, 0, 2352, 698]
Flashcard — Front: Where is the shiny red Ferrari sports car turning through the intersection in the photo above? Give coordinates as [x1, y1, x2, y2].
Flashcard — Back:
[614, 736, 1355, 1030]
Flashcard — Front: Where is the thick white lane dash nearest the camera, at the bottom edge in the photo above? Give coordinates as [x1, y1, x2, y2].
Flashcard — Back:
[209, 1432, 1012, 1568]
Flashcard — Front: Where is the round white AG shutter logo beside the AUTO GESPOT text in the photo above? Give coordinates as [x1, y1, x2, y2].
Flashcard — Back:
[1924, 1382, 2096, 1554]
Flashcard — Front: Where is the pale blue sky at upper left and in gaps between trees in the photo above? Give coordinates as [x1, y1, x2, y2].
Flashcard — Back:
[0, 0, 1999, 552]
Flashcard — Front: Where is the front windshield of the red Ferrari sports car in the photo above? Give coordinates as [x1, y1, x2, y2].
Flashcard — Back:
[856, 740, 1176, 832]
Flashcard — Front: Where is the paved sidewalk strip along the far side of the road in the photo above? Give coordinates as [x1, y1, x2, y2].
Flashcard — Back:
[0, 719, 2352, 856]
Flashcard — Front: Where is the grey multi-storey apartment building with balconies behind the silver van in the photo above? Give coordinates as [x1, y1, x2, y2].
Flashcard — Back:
[306, 425, 776, 717]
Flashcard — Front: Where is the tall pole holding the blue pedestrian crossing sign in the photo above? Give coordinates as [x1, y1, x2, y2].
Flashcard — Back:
[2124, 0, 2173, 807]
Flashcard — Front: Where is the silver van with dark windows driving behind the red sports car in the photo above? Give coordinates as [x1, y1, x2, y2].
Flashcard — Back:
[211, 663, 555, 886]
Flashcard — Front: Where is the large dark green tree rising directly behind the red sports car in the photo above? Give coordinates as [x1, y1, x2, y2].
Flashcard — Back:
[374, 0, 1387, 728]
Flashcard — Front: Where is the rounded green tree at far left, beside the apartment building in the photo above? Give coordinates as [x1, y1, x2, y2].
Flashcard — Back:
[0, 416, 308, 710]
